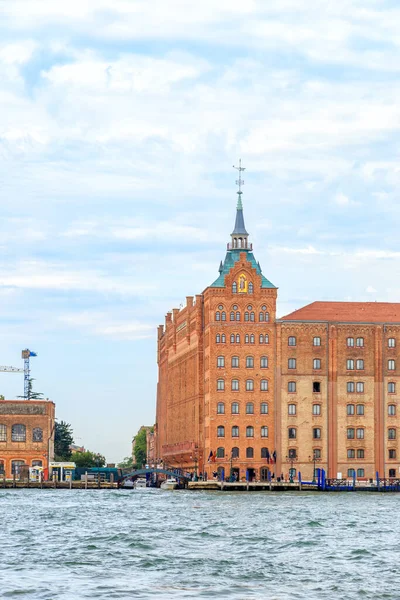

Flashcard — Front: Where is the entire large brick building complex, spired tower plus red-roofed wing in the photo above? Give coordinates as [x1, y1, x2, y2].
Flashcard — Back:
[155, 191, 400, 480]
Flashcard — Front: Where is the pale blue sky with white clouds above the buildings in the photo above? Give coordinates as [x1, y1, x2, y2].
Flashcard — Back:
[0, 0, 400, 461]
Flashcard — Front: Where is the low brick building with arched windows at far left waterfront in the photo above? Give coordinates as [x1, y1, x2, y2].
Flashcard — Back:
[0, 400, 55, 478]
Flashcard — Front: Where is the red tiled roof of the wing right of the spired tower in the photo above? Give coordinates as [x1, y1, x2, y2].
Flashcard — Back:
[281, 302, 400, 323]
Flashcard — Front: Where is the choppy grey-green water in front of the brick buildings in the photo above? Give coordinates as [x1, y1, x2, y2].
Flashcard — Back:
[0, 490, 400, 600]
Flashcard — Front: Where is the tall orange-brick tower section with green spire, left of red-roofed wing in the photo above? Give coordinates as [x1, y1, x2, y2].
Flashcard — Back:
[156, 166, 277, 480]
